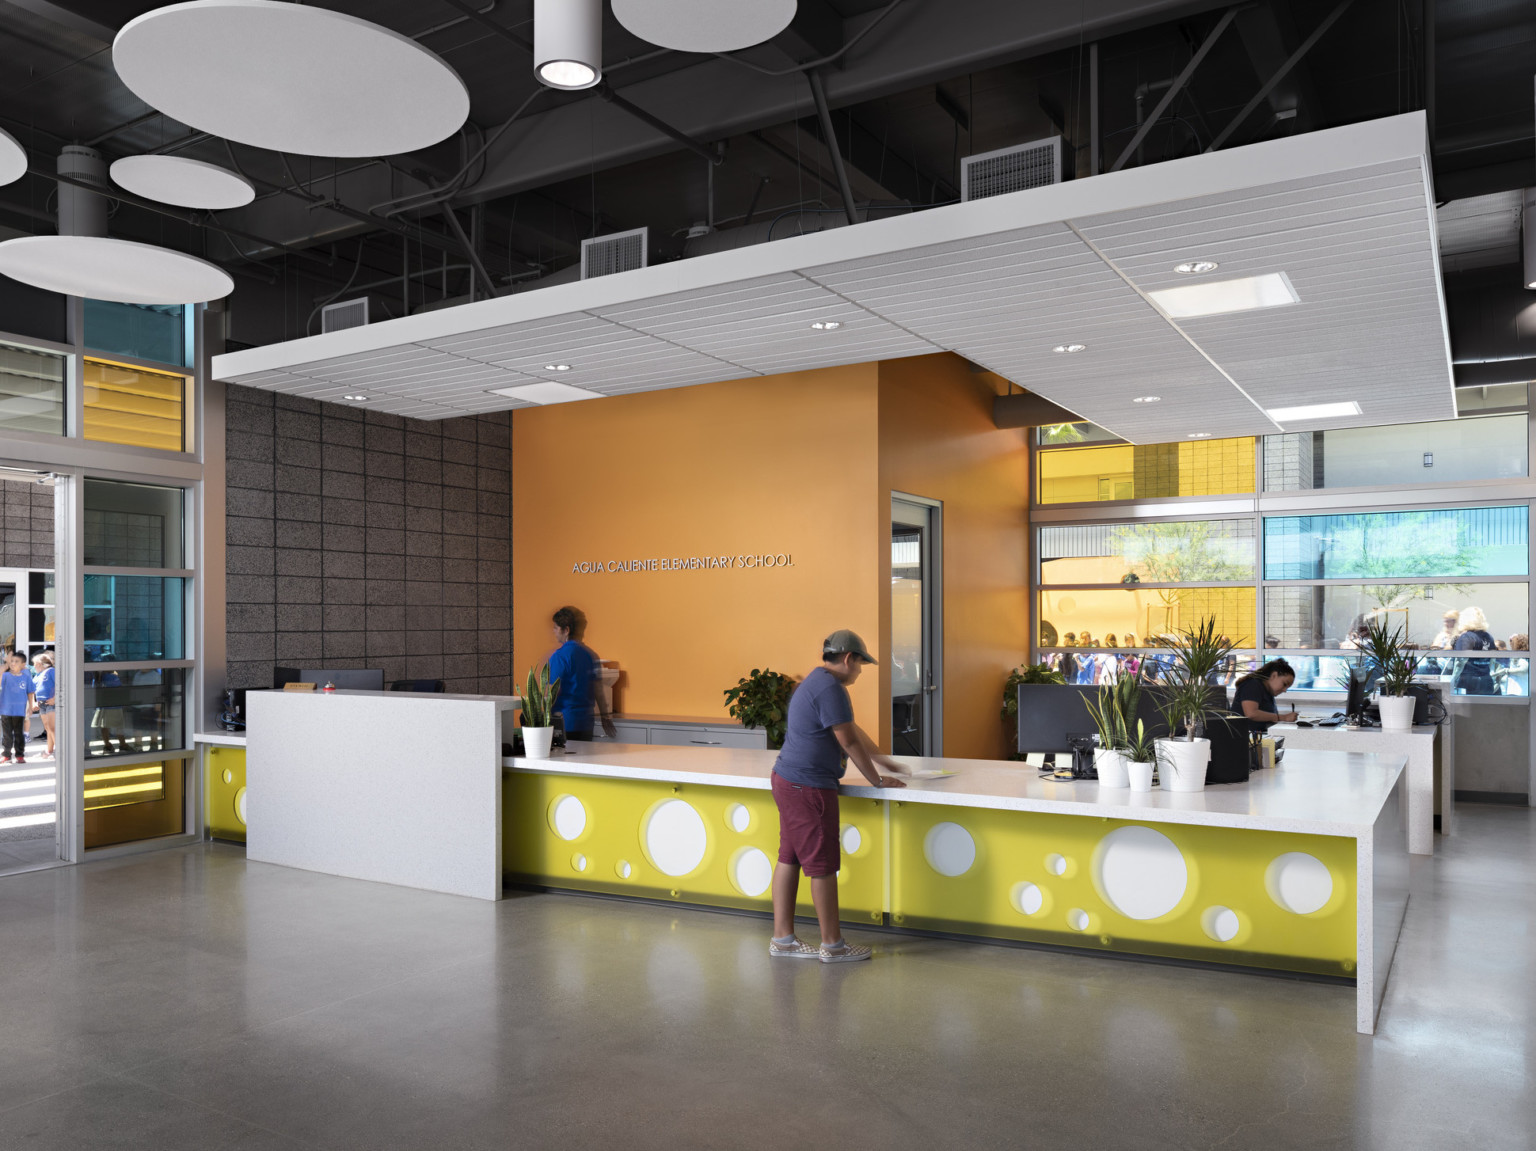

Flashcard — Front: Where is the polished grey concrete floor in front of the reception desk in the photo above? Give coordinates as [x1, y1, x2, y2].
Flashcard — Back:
[0, 807, 1536, 1151]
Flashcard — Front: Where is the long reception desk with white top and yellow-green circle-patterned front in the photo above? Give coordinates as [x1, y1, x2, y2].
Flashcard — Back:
[502, 744, 1407, 1033]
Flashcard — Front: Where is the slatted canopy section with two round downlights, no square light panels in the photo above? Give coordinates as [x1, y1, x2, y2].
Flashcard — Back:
[805, 224, 1267, 443]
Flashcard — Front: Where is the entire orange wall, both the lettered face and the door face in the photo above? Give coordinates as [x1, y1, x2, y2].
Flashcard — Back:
[511, 355, 1028, 758]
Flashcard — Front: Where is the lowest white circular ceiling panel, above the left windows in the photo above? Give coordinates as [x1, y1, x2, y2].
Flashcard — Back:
[0, 235, 235, 304]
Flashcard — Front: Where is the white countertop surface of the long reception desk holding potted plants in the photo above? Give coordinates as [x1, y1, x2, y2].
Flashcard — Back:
[502, 744, 1405, 836]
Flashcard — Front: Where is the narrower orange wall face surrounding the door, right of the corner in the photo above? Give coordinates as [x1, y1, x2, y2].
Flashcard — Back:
[880, 355, 1029, 759]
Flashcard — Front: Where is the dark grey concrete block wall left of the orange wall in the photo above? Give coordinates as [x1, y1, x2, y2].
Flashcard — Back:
[226, 386, 511, 695]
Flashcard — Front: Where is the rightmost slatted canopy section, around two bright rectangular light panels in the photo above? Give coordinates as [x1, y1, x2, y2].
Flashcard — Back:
[1080, 163, 1455, 430]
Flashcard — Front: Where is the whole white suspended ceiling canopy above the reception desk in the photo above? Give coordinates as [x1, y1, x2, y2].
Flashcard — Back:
[214, 112, 1456, 443]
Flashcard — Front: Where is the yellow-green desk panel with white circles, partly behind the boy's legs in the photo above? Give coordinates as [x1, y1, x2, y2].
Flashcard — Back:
[502, 771, 885, 924]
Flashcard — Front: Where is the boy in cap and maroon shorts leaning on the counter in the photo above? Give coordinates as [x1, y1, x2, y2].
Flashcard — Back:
[768, 629, 906, 964]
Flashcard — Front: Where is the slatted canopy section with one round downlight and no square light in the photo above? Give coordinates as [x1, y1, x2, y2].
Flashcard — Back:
[598, 272, 943, 375]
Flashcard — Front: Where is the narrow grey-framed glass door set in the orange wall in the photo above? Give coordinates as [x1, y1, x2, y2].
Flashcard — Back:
[889, 496, 943, 756]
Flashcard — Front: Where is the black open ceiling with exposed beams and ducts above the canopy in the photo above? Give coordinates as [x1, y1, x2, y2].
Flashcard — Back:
[0, 0, 1536, 343]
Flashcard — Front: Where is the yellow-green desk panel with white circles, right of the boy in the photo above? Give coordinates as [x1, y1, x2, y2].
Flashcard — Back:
[889, 801, 1356, 977]
